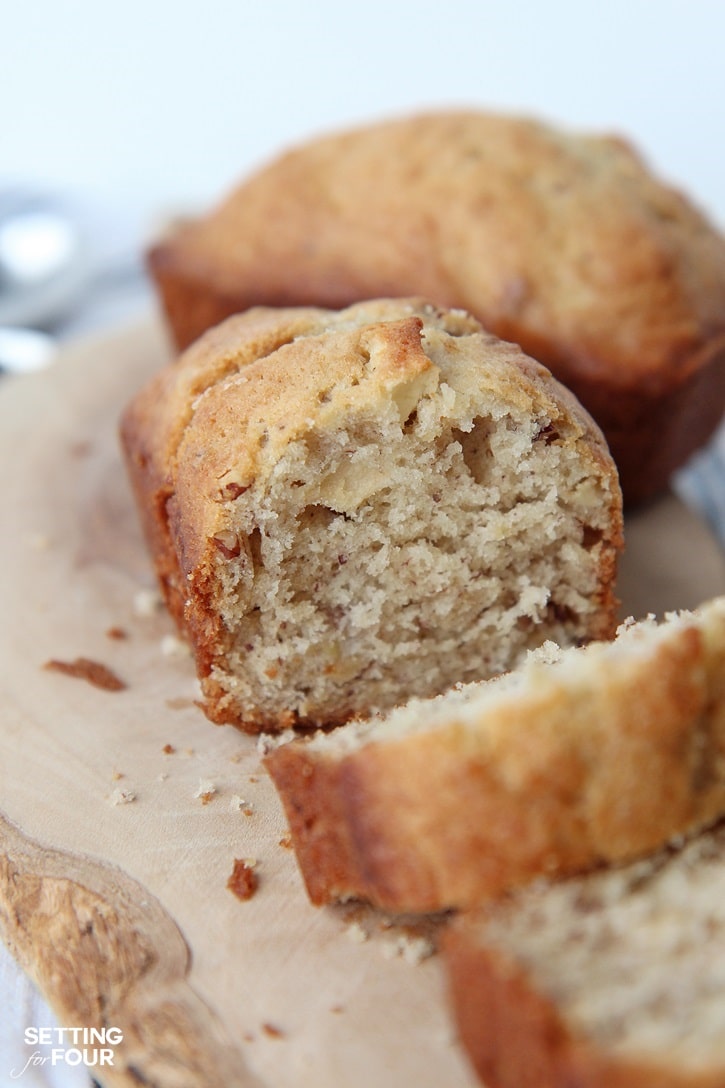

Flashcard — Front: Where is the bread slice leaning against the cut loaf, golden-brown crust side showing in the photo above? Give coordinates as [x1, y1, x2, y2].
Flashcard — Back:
[266, 597, 725, 911]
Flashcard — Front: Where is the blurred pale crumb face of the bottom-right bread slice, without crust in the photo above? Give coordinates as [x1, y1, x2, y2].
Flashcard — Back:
[477, 825, 725, 1066]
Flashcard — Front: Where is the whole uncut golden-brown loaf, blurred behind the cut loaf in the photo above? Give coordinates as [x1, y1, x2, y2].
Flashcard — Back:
[149, 111, 725, 503]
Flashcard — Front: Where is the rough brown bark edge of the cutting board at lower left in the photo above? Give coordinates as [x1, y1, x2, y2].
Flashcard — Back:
[0, 817, 258, 1088]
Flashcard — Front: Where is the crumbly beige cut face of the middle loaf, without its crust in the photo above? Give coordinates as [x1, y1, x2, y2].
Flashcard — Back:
[199, 302, 616, 724]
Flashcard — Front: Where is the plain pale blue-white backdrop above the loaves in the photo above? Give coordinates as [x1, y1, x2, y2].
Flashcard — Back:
[0, 0, 725, 238]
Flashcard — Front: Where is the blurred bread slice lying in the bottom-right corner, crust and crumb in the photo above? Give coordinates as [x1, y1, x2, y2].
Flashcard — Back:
[443, 824, 725, 1088]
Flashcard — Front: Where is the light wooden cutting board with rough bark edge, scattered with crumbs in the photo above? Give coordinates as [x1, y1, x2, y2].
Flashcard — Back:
[0, 320, 725, 1088]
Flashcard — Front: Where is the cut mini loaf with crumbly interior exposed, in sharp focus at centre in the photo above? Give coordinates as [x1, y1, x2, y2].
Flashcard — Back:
[122, 300, 622, 731]
